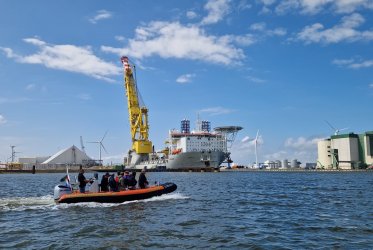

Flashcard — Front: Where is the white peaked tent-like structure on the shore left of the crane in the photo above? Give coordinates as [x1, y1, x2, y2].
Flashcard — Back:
[41, 145, 94, 167]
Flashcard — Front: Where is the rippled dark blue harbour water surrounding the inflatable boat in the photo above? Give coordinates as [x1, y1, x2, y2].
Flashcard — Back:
[0, 172, 373, 249]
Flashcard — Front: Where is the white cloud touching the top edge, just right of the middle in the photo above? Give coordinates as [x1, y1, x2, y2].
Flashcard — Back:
[201, 0, 231, 25]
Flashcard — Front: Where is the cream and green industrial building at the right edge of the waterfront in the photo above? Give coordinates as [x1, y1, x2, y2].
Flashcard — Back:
[317, 131, 373, 169]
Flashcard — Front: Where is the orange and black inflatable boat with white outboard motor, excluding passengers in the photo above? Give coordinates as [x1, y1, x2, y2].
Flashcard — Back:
[54, 182, 177, 204]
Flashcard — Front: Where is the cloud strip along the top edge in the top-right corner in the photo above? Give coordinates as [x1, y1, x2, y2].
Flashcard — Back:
[272, 0, 373, 15]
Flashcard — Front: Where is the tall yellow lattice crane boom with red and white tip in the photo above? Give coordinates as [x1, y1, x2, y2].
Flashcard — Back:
[121, 56, 152, 154]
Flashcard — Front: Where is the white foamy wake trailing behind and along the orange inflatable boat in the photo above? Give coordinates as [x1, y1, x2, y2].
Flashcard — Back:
[0, 193, 189, 211]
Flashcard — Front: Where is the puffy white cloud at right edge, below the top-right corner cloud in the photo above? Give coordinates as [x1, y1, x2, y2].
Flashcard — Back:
[296, 13, 373, 44]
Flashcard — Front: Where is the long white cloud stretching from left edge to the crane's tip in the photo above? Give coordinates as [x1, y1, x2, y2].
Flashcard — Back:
[0, 38, 121, 82]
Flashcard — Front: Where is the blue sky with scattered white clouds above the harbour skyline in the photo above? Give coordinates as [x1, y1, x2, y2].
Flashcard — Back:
[0, 0, 373, 165]
